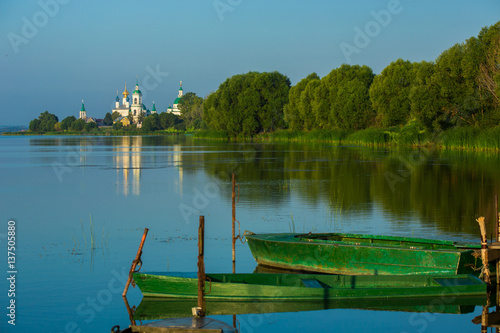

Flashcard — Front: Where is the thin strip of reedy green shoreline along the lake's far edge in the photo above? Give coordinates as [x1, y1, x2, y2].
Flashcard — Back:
[1, 126, 500, 152]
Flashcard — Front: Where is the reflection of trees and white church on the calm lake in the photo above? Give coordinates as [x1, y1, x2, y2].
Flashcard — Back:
[26, 136, 500, 238]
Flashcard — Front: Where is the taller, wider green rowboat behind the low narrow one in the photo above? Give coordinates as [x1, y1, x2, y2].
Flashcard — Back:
[245, 233, 482, 275]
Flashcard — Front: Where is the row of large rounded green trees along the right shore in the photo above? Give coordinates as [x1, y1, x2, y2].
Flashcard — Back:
[203, 22, 500, 136]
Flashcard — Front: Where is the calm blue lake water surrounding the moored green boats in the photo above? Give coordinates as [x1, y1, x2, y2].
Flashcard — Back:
[0, 136, 500, 333]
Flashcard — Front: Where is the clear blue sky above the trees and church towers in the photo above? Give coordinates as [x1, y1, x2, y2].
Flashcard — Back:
[0, 0, 500, 125]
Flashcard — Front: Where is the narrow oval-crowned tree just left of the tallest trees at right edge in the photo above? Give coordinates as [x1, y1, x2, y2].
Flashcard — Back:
[370, 59, 415, 127]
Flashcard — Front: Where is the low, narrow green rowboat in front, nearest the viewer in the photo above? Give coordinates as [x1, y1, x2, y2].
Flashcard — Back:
[133, 273, 486, 301]
